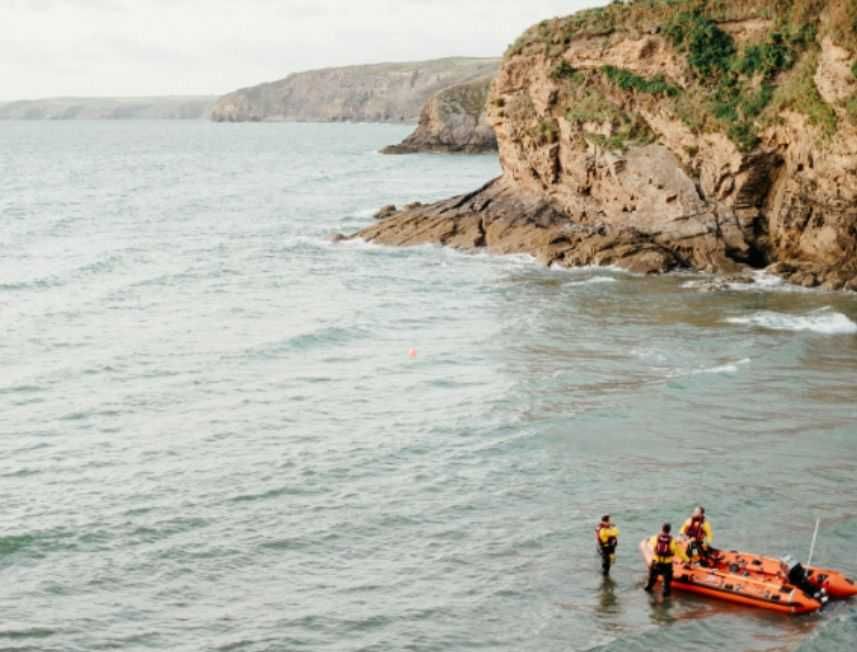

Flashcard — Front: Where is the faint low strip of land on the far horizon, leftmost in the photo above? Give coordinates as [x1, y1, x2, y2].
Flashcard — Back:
[0, 95, 216, 120]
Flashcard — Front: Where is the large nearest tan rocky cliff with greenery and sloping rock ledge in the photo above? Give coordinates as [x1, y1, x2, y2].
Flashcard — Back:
[352, 0, 857, 289]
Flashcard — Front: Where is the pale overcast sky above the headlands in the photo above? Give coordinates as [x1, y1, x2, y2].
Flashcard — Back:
[0, 0, 606, 100]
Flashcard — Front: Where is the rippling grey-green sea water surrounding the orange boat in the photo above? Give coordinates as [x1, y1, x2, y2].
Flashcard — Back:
[0, 122, 857, 652]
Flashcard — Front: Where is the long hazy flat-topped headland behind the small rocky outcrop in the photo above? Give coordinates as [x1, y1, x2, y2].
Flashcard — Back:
[210, 58, 499, 122]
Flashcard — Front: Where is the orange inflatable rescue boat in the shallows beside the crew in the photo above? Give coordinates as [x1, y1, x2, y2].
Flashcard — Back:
[640, 539, 847, 614]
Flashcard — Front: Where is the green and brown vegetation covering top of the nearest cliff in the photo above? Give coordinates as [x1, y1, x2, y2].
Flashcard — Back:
[506, 0, 844, 151]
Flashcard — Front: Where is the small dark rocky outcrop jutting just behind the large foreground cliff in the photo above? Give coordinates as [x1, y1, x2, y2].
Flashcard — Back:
[382, 75, 497, 154]
